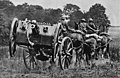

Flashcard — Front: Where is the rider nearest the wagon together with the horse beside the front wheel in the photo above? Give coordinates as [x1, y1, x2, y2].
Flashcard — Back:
[60, 15, 85, 64]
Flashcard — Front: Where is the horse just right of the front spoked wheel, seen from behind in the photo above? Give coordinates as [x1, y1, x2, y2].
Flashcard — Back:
[69, 22, 84, 65]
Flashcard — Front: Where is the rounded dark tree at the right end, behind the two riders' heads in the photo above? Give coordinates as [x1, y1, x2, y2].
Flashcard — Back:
[84, 3, 110, 31]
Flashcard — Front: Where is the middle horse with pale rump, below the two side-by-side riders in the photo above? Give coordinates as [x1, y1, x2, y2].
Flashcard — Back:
[84, 36, 97, 65]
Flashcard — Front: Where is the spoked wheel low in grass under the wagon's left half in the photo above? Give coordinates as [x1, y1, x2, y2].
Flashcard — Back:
[23, 49, 38, 70]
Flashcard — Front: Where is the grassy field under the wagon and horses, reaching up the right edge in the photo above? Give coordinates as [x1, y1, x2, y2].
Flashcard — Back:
[0, 27, 120, 78]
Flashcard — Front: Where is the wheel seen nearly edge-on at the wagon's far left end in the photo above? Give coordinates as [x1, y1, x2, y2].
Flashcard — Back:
[9, 18, 18, 57]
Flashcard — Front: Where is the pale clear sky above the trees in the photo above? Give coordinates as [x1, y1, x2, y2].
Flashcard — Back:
[10, 0, 120, 26]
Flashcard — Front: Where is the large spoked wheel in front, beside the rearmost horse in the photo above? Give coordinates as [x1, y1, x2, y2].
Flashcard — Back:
[58, 37, 73, 70]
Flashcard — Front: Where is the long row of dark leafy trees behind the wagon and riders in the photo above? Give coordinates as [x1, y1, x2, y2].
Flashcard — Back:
[0, 0, 110, 45]
